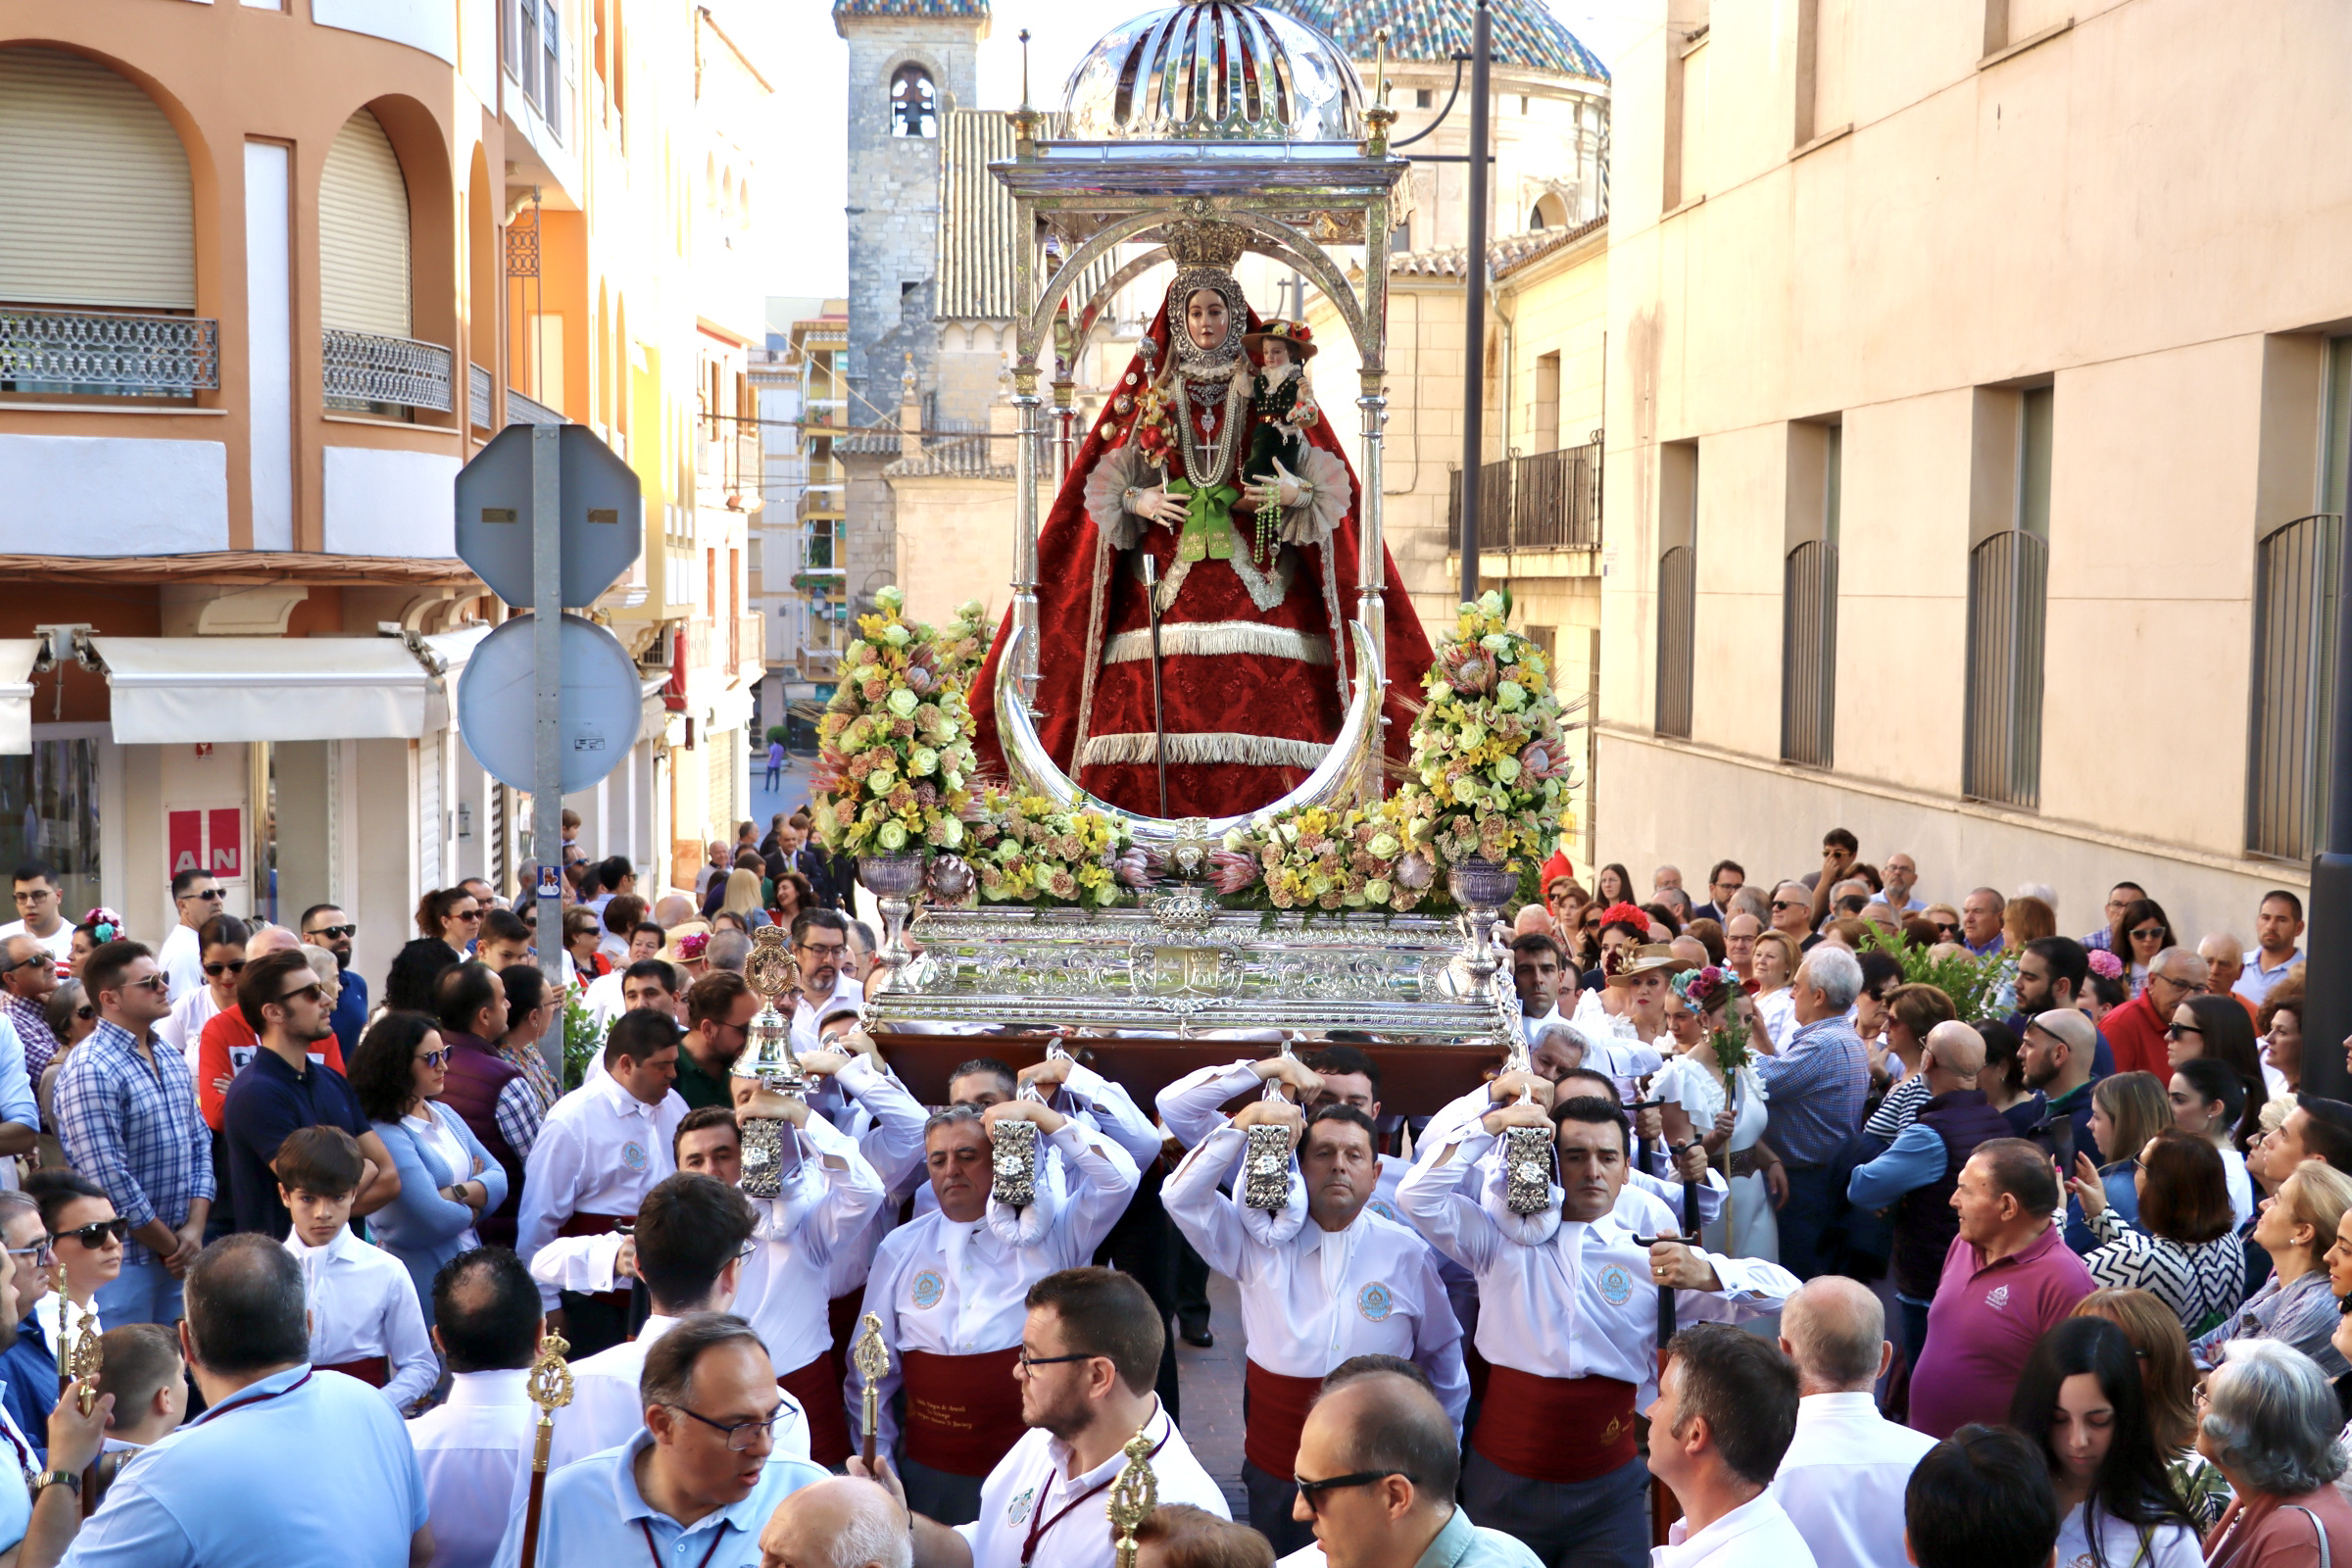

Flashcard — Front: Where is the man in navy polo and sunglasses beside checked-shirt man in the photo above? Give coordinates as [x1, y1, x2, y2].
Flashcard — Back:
[221, 953, 400, 1242]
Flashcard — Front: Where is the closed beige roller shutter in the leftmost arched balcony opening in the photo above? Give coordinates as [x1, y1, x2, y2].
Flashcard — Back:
[0, 49, 195, 311]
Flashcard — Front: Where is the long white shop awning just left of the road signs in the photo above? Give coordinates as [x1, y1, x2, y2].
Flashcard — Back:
[89, 637, 435, 745]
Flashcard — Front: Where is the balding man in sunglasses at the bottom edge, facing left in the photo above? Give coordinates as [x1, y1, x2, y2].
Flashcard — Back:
[1287, 1356, 1541, 1568]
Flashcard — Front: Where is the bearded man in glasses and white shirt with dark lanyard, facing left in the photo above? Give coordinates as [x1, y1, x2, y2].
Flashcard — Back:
[849, 1269, 1232, 1568]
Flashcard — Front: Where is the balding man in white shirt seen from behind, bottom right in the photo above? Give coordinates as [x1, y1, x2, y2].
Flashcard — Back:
[1771, 1274, 1936, 1568]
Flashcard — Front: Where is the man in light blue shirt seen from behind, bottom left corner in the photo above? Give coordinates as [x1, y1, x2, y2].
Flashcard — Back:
[66, 1237, 432, 1568]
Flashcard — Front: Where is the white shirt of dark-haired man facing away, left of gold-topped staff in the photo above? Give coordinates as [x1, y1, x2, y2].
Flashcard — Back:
[410, 1368, 536, 1568]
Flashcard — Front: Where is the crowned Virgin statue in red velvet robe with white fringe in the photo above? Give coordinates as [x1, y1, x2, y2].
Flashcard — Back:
[974, 220, 1430, 815]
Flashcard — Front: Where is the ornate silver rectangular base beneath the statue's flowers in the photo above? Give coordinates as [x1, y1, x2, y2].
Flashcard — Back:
[868, 906, 1517, 1044]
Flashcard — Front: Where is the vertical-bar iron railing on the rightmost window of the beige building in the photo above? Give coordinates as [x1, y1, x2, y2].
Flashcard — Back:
[2246, 513, 2345, 860]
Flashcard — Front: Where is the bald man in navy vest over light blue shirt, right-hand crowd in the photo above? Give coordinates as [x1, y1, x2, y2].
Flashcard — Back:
[1846, 1020, 2013, 1366]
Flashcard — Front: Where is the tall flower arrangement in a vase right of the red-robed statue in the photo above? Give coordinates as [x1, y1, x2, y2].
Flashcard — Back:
[1411, 592, 1569, 865]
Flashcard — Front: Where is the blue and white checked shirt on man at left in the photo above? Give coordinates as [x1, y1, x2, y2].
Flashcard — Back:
[57, 1018, 212, 1262]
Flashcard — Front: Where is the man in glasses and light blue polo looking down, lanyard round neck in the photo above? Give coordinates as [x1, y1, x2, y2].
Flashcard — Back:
[514, 1316, 827, 1568]
